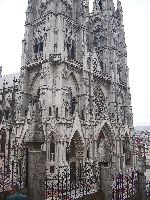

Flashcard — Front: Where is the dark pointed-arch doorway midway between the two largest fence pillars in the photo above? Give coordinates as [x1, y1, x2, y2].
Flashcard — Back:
[69, 131, 84, 181]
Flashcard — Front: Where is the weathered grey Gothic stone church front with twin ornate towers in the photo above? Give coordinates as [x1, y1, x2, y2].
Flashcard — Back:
[1, 0, 133, 173]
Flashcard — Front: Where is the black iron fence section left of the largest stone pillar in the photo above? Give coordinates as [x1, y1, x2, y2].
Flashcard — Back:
[0, 149, 28, 192]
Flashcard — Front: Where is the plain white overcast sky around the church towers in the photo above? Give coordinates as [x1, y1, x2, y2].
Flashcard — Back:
[0, 0, 150, 125]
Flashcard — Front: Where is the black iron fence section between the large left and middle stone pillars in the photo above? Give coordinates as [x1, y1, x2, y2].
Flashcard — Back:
[45, 165, 100, 200]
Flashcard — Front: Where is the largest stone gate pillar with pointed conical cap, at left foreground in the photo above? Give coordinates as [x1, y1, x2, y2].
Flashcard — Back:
[25, 102, 46, 200]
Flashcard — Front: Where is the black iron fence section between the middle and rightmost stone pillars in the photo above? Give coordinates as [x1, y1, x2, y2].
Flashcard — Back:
[112, 170, 138, 200]
